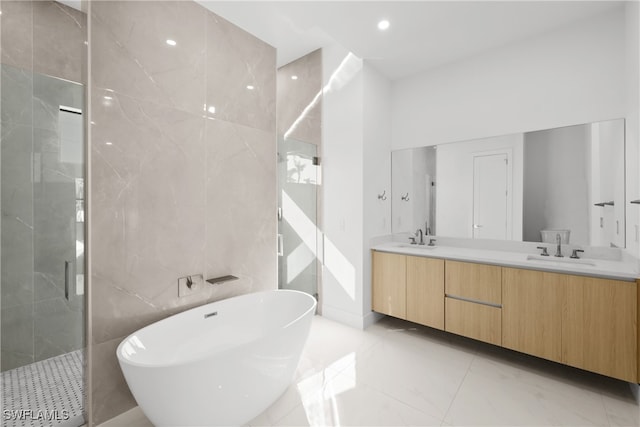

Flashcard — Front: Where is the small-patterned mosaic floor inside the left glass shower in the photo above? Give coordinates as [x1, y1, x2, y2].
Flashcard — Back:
[1, 350, 84, 427]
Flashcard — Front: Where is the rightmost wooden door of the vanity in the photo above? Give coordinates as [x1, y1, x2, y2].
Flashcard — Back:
[562, 275, 638, 382]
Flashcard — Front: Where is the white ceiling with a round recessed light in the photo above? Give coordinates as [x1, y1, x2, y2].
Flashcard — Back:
[198, 0, 624, 80]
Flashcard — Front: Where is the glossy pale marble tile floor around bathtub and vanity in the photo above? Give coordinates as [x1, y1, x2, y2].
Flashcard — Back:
[101, 316, 640, 427]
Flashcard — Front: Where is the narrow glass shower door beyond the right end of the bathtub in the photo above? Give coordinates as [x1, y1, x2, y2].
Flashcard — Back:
[278, 139, 319, 299]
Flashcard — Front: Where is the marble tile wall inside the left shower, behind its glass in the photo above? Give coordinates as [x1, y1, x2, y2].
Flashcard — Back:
[0, 1, 86, 370]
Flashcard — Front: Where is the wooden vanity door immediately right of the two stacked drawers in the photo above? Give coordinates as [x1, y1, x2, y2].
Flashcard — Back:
[502, 268, 568, 362]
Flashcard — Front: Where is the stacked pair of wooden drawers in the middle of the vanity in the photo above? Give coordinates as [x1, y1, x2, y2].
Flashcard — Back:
[445, 260, 502, 345]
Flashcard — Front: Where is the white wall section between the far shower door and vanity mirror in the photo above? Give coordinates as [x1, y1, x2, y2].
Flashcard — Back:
[322, 45, 391, 328]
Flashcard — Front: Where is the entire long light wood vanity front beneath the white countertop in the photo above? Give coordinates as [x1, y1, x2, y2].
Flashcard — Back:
[372, 251, 640, 383]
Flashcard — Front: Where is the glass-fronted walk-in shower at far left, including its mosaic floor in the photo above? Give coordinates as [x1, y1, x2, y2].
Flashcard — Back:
[0, 1, 86, 427]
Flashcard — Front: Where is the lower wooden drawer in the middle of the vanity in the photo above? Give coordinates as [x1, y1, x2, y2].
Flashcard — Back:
[444, 298, 502, 345]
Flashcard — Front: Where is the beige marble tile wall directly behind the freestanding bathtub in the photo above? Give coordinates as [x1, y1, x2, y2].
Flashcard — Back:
[89, 1, 277, 424]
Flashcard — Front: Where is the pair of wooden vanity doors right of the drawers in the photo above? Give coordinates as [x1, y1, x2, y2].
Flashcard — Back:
[502, 268, 638, 382]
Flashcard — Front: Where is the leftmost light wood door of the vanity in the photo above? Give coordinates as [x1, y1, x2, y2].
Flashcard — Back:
[371, 251, 407, 319]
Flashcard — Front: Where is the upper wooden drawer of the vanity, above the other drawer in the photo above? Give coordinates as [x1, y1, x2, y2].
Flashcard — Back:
[445, 260, 502, 305]
